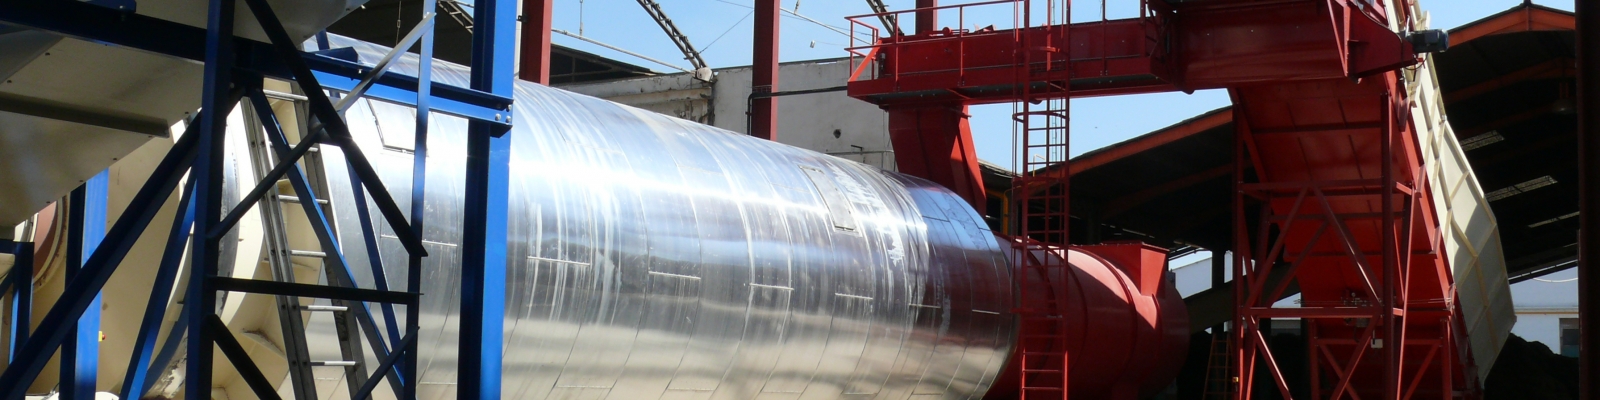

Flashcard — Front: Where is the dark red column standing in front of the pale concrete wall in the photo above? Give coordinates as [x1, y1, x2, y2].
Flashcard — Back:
[750, 0, 779, 141]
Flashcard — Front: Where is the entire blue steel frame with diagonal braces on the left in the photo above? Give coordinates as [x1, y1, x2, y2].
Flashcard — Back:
[0, 0, 517, 393]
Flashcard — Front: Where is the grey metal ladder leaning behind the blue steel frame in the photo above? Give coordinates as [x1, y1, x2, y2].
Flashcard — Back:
[242, 91, 368, 400]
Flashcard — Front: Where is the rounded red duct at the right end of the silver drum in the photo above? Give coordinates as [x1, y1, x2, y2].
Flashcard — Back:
[986, 242, 1189, 400]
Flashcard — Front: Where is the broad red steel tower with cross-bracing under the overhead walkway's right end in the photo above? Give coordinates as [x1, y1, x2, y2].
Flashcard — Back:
[1230, 72, 1477, 398]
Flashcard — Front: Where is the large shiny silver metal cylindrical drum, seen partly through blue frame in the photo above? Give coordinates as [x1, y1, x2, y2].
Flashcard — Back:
[312, 36, 1016, 400]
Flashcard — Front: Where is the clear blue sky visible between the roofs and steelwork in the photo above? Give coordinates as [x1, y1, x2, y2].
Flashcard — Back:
[537, 0, 1573, 165]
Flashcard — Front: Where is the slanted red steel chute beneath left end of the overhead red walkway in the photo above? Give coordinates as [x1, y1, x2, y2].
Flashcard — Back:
[886, 104, 987, 213]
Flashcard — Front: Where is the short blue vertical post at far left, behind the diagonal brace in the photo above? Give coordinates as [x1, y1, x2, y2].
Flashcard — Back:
[61, 171, 110, 400]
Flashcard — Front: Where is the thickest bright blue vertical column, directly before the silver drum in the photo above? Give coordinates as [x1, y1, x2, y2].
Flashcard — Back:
[459, 0, 517, 395]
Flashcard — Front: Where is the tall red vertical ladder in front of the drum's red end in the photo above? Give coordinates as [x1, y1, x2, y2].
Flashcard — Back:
[1011, 2, 1070, 400]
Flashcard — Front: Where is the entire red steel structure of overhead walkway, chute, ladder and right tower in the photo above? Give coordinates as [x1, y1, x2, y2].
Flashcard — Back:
[848, 0, 1480, 400]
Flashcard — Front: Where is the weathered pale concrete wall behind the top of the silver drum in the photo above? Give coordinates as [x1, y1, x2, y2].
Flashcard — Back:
[560, 59, 894, 171]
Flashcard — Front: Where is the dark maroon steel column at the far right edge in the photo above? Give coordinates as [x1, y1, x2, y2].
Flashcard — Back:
[1576, 0, 1600, 400]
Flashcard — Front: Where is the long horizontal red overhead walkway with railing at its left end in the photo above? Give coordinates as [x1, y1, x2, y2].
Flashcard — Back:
[848, 0, 1414, 106]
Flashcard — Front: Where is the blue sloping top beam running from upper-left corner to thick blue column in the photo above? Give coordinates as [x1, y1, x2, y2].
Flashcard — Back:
[0, 0, 515, 126]
